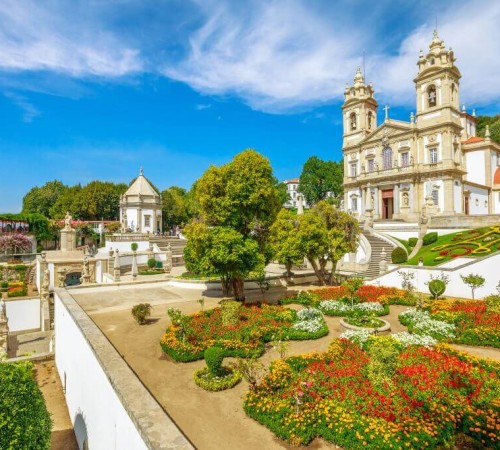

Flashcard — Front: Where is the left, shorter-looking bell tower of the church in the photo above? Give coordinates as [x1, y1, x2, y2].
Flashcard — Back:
[342, 67, 378, 148]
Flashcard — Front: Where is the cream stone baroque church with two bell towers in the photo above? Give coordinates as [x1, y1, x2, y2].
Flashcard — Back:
[342, 31, 500, 222]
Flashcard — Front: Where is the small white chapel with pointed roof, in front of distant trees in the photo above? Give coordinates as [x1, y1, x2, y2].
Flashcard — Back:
[120, 168, 162, 233]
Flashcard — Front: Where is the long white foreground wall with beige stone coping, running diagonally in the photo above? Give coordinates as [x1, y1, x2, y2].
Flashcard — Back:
[54, 289, 192, 450]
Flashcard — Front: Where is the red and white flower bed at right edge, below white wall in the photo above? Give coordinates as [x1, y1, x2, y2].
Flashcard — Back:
[399, 296, 500, 348]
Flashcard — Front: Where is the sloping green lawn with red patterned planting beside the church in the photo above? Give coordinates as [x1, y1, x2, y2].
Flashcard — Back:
[406, 225, 500, 266]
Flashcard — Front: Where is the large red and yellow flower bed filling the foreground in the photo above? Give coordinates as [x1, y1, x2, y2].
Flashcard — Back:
[244, 340, 500, 450]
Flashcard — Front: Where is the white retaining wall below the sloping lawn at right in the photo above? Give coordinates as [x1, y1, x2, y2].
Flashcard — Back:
[367, 254, 500, 299]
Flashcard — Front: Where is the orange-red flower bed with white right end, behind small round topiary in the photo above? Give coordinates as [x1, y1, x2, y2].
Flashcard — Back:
[161, 304, 328, 362]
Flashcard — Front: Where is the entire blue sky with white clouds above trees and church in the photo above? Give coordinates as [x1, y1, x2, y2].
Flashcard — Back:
[0, 0, 500, 212]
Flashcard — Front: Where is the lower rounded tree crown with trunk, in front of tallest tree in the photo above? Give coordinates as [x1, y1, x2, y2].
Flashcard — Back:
[184, 223, 264, 301]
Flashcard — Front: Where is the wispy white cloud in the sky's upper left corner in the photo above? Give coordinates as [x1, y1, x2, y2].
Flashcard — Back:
[0, 0, 143, 77]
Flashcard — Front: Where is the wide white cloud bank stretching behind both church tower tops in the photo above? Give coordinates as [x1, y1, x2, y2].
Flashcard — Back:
[163, 0, 500, 112]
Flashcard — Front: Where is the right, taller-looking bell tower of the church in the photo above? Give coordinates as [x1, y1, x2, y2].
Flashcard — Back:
[413, 30, 461, 129]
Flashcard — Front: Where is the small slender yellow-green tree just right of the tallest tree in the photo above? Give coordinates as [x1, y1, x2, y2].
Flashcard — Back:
[270, 208, 304, 276]
